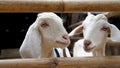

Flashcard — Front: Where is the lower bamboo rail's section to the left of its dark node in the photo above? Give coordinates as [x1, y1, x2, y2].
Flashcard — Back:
[0, 58, 54, 68]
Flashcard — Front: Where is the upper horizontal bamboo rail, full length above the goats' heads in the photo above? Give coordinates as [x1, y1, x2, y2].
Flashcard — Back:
[0, 0, 120, 12]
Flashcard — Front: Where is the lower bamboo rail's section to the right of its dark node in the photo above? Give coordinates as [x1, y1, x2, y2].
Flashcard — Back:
[56, 56, 120, 68]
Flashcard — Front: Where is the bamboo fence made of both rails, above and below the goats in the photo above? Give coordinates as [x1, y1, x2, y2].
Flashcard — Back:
[0, 0, 120, 68]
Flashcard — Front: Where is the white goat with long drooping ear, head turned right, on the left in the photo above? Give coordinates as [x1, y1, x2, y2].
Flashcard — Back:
[19, 12, 70, 58]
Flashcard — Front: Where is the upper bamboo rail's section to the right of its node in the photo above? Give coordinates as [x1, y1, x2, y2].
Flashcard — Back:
[64, 0, 120, 12]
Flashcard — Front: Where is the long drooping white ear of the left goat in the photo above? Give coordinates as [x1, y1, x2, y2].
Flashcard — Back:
[20, 23, 41, 58]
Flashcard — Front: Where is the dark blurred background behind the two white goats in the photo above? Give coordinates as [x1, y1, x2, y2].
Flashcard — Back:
[0, 12, 120, 59]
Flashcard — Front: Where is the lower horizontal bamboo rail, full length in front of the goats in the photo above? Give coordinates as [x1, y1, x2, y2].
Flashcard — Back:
[0, 56, 120, 68]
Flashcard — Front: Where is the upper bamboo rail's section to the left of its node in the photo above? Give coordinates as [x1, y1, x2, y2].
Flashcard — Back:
[0, 0, 63, 12]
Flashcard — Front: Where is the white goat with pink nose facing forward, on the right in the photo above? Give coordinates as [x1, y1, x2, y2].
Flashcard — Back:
[69, 13, 115, 57]
